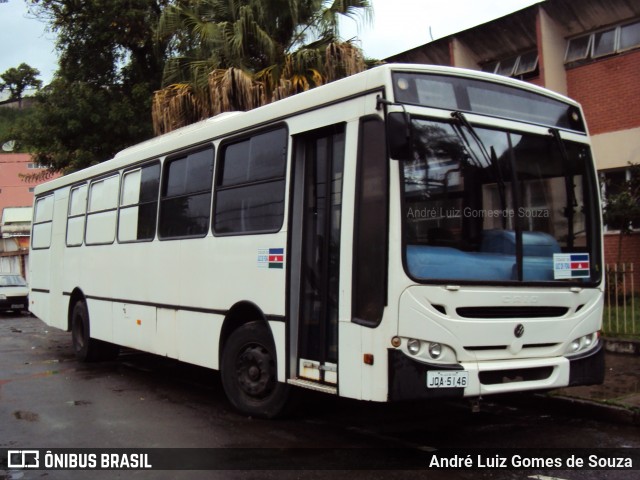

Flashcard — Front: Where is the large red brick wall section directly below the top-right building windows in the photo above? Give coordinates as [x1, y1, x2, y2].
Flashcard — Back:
[567, 50, 640, 135]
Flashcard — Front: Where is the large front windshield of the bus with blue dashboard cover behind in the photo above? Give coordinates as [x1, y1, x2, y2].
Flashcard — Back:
[401, 113, 601, 284]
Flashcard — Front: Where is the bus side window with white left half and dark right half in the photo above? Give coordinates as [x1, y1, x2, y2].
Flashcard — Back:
[118, 162, 160, 242]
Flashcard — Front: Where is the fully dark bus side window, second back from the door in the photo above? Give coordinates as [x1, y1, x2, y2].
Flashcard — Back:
[158, 146, 213, 239]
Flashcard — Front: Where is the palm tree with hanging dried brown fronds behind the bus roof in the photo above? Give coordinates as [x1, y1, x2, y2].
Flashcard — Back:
[153, 0, 372, 134]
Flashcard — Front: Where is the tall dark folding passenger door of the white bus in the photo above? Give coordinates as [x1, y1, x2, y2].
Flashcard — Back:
[289, 125, 345, 387]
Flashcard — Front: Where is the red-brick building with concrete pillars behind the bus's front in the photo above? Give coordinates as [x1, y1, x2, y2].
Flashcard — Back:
[386, 0, 640, 288]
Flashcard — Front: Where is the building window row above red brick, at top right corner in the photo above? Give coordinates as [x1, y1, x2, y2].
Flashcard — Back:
[564, 22, 640, 63]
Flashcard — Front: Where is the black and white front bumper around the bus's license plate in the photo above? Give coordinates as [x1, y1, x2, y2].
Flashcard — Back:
[388, 341, 604, 401]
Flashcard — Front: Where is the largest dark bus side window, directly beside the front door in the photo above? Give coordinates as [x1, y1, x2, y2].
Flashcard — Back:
[214, 128, 288, 235]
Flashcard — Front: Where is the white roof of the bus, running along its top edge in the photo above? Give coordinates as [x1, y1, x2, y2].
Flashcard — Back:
[35, 63, 578, 196]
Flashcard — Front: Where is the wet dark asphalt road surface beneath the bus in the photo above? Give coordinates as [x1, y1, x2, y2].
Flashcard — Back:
[0, 314, 640, 480]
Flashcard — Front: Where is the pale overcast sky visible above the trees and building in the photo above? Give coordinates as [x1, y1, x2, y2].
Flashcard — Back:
[0, 0, 540, 96]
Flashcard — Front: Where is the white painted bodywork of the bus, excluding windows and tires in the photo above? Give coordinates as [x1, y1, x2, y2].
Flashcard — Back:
[30, 65, 602, 401]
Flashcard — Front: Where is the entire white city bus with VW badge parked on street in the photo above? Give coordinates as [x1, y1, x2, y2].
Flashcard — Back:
[30, 65, 604, 417]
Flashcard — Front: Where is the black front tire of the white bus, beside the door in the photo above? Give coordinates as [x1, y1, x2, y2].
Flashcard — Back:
[220, 322, 290, 418]
